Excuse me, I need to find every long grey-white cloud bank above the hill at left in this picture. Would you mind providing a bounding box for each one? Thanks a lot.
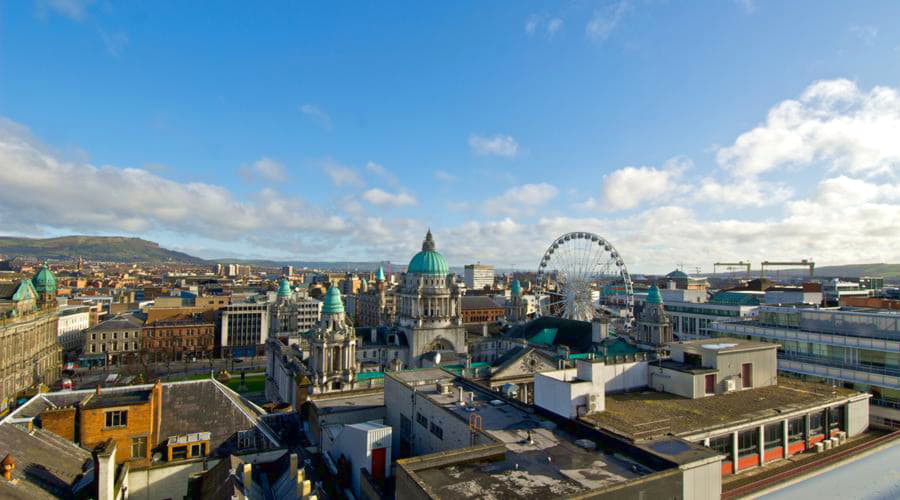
[0,120,347,240]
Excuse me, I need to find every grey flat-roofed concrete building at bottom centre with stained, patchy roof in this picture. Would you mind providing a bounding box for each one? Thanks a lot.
[384,368,721,499]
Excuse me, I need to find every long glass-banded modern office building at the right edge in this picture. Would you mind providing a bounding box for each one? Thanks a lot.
[713,306,900,428]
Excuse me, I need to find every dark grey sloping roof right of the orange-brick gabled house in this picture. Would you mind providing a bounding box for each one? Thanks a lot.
[156,379,277,456]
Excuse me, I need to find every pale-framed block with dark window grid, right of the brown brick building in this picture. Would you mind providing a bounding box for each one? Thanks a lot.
[217,302,271,357]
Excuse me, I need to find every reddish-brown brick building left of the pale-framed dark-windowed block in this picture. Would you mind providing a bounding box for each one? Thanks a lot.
[142,314,216,361]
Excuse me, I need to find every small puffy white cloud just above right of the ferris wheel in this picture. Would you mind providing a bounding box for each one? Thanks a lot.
[601,157,691,210]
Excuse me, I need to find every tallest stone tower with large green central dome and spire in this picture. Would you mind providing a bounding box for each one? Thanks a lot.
[397,230,467,367]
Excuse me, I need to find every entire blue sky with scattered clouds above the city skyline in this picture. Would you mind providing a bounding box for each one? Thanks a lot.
[0,0,900,272]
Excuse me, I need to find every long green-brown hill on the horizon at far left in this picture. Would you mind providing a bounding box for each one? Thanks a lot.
[0,236,204,264]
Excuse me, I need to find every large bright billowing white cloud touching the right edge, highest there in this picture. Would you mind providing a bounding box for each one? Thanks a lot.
[716,80,900,176]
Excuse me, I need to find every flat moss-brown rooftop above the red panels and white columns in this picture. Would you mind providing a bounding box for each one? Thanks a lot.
[583,378,860,441]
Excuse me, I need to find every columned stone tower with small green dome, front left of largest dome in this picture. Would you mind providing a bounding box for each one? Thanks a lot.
[309,286,359,393]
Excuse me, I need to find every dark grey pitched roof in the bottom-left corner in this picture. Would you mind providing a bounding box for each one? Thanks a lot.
[0,424,93,499]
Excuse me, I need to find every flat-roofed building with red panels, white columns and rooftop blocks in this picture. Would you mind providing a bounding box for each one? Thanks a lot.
[534,338,870,474]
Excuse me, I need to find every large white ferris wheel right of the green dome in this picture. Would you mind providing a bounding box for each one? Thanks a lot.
[537,232,634,325]
